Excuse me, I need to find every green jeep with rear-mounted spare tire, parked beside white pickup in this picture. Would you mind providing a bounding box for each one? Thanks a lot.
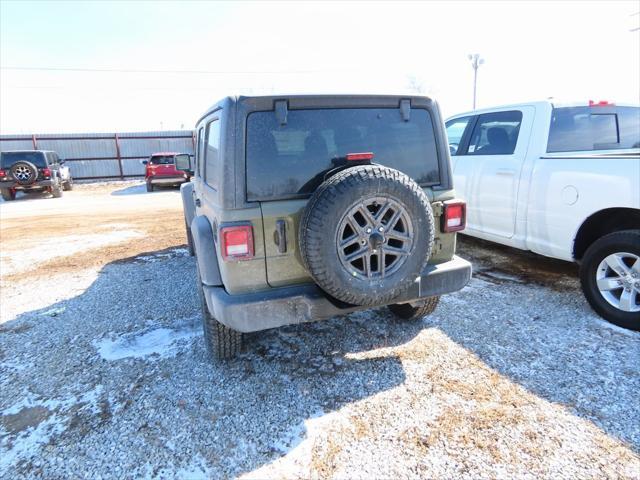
[176,95,471,359]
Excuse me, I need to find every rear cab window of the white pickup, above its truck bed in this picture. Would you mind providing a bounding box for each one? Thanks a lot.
[547,106,640,153]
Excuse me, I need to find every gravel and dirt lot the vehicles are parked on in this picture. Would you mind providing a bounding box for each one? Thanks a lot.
[0,183,640,479]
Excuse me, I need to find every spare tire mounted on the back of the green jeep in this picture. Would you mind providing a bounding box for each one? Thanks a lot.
[298,165,434,305]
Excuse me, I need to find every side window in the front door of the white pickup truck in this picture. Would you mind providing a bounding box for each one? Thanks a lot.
[467,110,522,155]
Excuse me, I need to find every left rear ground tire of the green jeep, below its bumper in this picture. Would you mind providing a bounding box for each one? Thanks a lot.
[196,263,244,360]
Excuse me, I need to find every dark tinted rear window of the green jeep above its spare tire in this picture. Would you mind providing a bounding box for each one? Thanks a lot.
[246,108,440,201]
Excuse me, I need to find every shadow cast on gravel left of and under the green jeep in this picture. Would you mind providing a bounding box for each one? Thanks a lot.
[0,251,412,477]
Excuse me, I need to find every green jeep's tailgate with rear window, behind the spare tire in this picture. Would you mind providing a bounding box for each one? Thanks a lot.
[246,107,440,287]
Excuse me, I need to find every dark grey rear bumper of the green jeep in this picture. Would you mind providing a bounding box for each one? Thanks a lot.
[204,256,471,332]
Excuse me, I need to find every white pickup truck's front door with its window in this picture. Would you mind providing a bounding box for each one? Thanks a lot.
[448,106,535,238]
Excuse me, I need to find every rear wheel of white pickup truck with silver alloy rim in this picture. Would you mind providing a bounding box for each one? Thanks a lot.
[580,230,640,331]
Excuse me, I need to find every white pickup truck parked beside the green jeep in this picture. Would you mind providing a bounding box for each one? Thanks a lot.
[446,101,640,330]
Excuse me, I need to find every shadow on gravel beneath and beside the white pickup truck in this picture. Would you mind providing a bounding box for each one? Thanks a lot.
[444,237,640,452]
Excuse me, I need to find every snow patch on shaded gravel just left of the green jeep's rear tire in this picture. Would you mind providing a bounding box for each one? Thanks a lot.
[94,326,199,361]
